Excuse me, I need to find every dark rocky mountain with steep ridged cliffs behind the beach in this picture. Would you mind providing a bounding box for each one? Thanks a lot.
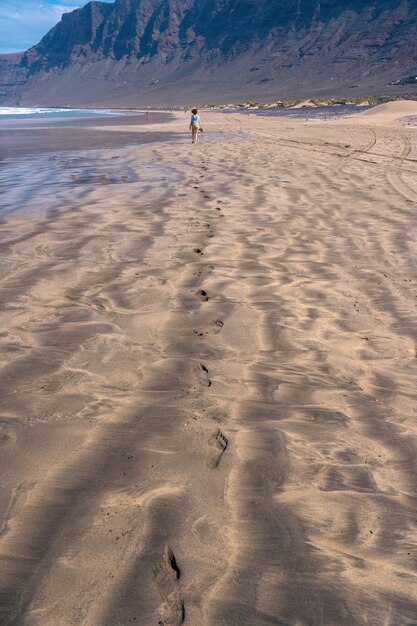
[0,0,417,106]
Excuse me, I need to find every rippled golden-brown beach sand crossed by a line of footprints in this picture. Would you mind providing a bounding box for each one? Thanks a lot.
[0,105,417,626]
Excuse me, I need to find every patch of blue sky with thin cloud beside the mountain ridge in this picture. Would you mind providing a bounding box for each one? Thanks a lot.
[0,0,113,53]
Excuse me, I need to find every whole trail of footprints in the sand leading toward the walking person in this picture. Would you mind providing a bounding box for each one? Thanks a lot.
[152,158,228,626]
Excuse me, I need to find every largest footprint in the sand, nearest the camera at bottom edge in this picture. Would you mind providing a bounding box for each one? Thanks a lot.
[152,546,185,626]
